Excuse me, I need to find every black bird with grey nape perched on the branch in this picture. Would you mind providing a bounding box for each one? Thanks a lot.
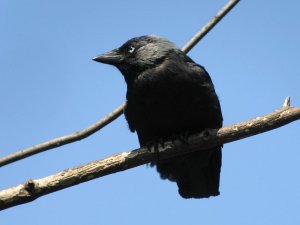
[94,35,223,198]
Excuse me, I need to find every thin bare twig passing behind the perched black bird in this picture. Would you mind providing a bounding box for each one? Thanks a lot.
[0,0,239,167]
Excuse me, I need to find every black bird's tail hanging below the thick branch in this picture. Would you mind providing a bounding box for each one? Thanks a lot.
[157,147,222,198]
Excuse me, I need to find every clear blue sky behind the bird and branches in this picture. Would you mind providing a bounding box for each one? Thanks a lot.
[0,0,300,225]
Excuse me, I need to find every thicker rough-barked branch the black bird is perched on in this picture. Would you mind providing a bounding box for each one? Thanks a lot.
[0,98,300,210]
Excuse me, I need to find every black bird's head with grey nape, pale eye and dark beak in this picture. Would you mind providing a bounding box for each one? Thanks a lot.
[93,35,180,79]
